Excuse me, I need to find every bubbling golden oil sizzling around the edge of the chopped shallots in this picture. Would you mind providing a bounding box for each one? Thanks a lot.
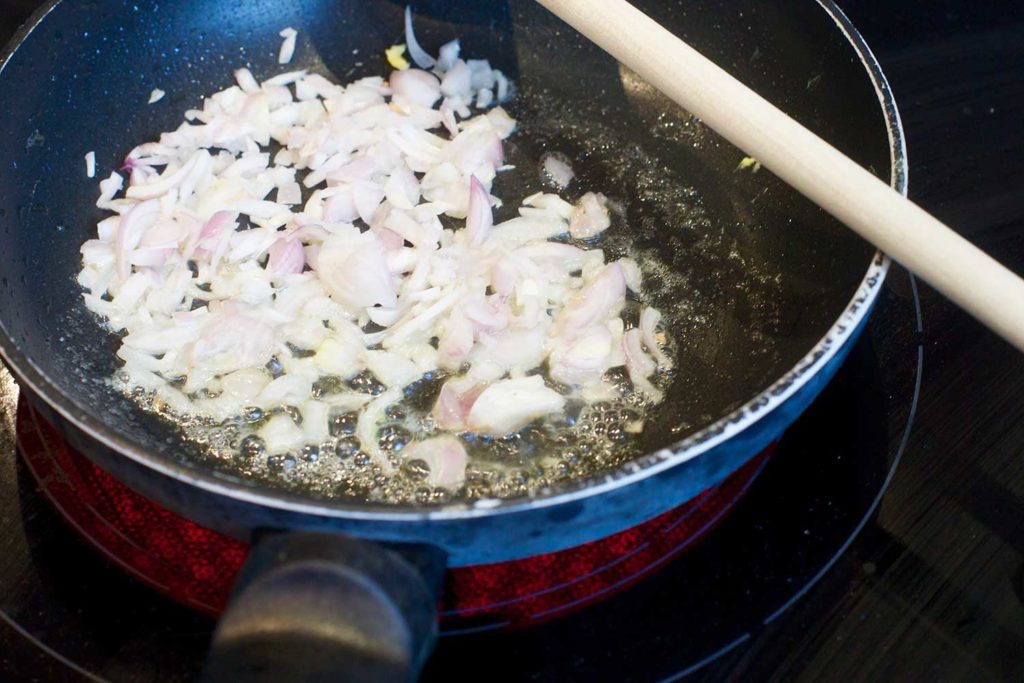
[110,82,761,504]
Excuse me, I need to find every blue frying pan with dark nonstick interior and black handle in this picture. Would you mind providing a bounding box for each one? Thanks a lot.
[0,0,906,680]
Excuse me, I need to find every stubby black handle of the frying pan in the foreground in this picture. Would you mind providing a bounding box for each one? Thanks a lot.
[201,531,446,683]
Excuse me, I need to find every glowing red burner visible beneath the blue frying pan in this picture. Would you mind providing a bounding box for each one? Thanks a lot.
[17,400,771,633]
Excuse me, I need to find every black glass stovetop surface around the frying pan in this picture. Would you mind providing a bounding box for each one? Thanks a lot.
[0,0,1024,682]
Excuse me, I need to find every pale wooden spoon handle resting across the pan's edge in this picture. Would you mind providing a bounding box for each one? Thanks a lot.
[538,0,1024,350]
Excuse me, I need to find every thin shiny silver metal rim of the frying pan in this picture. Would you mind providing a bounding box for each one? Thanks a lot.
[0,0,907,523]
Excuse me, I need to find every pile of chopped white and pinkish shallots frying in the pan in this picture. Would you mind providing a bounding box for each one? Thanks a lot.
[78,15,671,490]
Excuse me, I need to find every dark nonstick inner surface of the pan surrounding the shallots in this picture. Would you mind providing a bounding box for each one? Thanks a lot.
[0,0,890,504]
